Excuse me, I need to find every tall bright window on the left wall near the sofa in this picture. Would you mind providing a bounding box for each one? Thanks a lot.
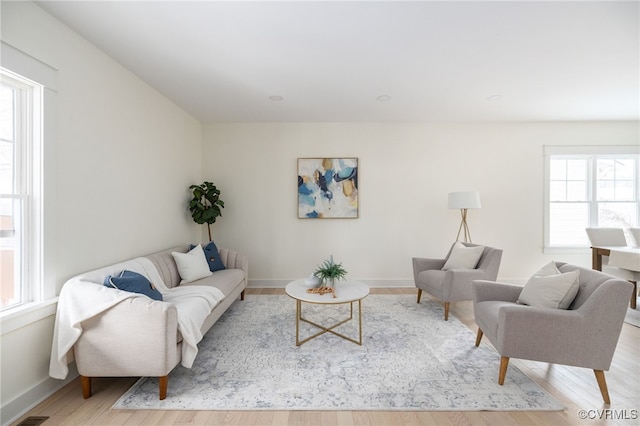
[0,68,43,310]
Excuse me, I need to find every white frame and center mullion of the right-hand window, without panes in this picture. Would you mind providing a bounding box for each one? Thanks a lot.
[543,145,640,253]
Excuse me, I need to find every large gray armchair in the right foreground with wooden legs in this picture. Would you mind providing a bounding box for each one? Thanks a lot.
[473,262,633,404]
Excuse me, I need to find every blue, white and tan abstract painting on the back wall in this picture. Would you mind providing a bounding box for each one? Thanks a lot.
[298,158,358,219]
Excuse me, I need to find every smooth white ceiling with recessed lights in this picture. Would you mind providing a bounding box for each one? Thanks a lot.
[37,1,640,122]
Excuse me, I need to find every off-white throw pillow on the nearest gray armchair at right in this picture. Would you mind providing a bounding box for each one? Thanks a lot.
[518,263,580,309]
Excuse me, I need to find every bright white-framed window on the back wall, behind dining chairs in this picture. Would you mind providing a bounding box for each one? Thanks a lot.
[545,146,640,249]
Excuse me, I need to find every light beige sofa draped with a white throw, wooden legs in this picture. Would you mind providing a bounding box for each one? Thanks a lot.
[49,245,248,399]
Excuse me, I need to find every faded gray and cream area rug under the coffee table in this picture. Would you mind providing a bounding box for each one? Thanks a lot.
[113,295,564,411]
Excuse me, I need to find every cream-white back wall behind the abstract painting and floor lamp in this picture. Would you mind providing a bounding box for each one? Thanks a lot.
[203,122,640,286]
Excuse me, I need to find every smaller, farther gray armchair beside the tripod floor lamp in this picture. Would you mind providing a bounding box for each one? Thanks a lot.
[413,243,502,321]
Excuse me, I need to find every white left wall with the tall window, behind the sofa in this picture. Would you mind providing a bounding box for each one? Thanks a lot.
[0,2,202,423]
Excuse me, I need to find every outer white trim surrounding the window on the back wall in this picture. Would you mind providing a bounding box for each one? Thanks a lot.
[543,145,640,254]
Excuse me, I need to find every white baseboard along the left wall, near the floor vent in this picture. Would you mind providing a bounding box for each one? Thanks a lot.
[0,362,82,426]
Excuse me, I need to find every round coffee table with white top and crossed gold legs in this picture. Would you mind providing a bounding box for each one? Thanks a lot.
[285,279,369,346]
